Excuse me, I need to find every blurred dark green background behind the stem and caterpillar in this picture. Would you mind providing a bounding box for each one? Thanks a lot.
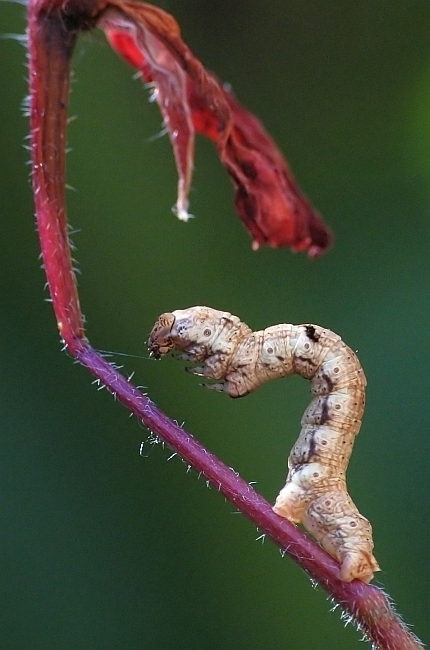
[0,0,430,650]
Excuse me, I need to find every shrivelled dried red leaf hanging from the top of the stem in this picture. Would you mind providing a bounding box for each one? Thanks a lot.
[98,0,331,257]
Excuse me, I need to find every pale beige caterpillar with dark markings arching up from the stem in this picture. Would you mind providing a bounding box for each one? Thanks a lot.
[148,307,379,582]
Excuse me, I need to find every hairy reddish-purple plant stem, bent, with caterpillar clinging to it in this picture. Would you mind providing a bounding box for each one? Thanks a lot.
[28,0,422,650]
